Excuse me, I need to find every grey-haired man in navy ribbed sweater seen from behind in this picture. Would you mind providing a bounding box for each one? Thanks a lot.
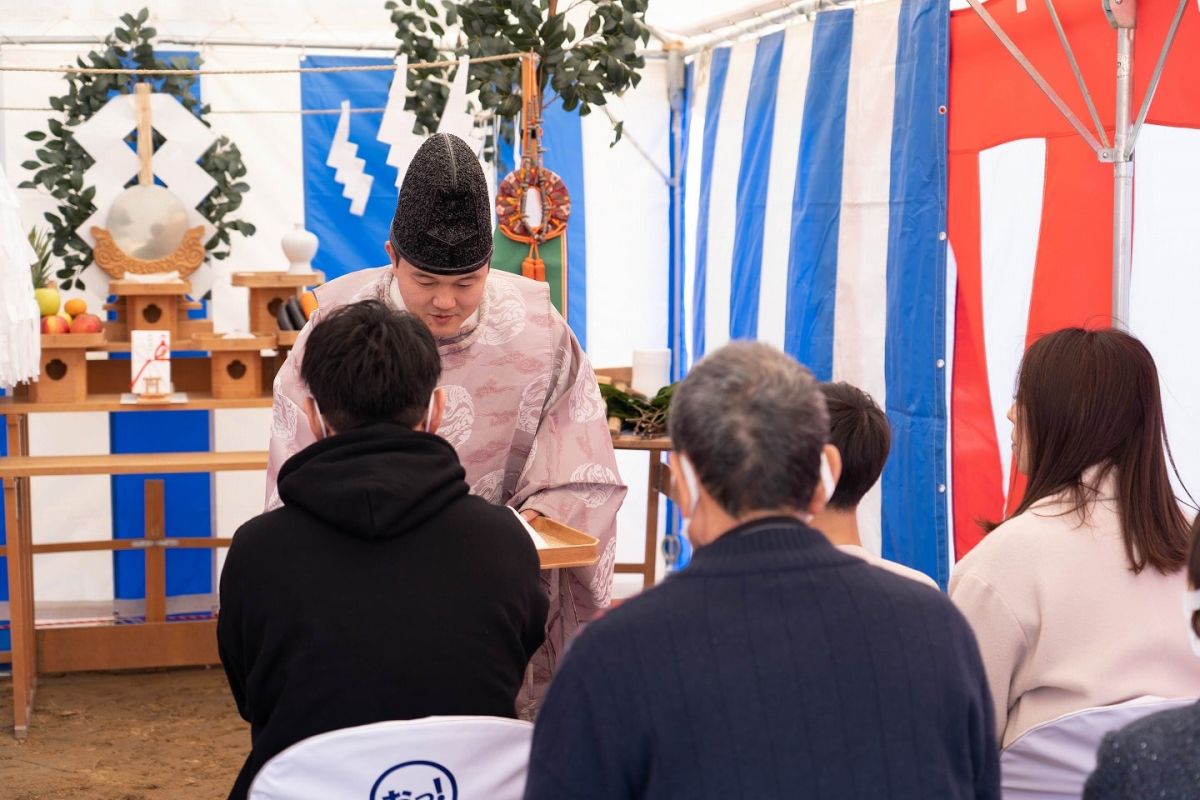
[526,343,1000,800]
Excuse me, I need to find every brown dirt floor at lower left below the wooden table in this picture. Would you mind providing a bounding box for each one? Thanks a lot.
[0,668,250,800]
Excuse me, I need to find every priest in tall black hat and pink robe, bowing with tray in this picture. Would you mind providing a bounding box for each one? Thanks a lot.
[266,133,625,718]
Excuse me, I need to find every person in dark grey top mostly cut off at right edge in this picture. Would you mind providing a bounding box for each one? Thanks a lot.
[1084,517,1200,800]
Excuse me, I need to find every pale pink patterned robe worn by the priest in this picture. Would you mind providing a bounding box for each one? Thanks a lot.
[266,267,625,718]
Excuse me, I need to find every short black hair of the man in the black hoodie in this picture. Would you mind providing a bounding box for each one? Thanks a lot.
[300,300,442,432]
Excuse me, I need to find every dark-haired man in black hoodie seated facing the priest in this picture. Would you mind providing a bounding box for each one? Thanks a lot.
[217,300,547,799]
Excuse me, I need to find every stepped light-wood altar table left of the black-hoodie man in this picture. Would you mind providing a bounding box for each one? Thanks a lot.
[0,393,271,738]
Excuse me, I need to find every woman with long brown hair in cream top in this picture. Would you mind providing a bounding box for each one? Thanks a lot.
[950,329,1200,746]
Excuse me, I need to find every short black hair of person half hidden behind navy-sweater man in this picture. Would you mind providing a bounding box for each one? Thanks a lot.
[821,383,892,511]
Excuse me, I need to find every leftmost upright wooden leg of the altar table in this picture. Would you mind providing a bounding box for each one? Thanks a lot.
[4,414,37,739]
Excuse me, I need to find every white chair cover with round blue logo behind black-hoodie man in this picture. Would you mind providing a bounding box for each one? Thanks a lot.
[250,716,533,800]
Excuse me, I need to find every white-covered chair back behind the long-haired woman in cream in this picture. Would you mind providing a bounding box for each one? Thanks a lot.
[1000,697,1195,800]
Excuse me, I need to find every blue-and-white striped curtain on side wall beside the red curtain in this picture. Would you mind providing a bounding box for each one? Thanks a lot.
[672,0,949,585]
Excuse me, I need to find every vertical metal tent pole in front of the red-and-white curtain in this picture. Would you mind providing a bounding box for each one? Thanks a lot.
[1112,28,1133,330]
